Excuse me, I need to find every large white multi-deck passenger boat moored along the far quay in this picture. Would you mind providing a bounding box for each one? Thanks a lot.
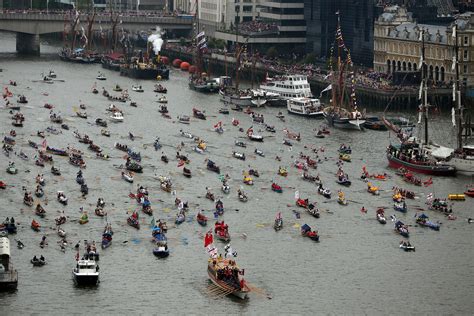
[260,75,313,106]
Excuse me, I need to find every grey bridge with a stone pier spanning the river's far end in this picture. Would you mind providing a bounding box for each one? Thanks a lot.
[0,12,193,55]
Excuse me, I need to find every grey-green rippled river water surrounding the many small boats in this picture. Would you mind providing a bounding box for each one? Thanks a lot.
[0,34,474,315]
